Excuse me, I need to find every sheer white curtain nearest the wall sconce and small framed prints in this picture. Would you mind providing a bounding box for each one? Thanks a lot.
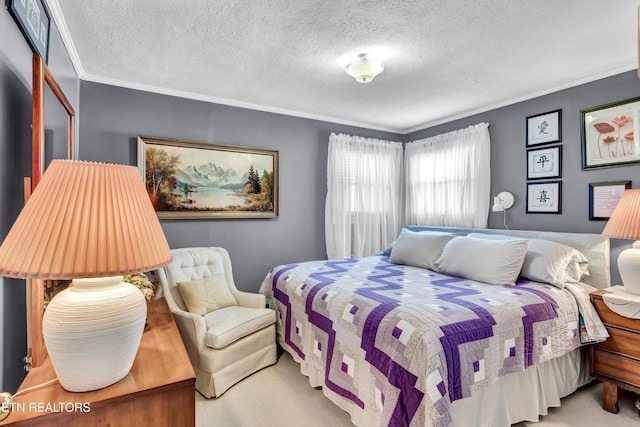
[405,123,491,228]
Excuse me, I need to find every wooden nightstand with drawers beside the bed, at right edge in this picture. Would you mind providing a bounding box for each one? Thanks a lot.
[589,290,640,414]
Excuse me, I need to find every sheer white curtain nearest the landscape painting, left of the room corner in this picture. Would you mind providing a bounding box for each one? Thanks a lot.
[325,133,402,259]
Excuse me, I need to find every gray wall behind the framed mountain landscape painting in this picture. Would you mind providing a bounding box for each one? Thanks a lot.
[79,81,401,292]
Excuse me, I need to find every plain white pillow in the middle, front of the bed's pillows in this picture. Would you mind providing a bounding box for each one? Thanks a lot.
[435,236,527,285]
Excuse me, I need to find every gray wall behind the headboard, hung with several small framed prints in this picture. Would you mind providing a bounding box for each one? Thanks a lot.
[404,71,640,284]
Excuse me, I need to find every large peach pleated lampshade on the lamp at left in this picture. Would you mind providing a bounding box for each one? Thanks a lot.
[0,160,171,280]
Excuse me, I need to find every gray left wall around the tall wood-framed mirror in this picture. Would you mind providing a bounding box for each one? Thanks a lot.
[0,7,80,392]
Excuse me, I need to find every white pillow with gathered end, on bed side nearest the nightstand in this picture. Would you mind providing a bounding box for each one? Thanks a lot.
[468,233,589,289]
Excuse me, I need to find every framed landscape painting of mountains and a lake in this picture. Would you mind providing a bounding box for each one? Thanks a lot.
[138,136,278,219]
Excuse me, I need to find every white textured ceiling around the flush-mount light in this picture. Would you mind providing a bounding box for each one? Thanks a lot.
[48,0,640,133]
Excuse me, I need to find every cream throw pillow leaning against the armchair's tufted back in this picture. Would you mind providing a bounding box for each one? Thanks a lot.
[176,273,238,315]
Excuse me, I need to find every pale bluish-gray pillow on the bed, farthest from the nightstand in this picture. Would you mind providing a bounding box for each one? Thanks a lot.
[389,228,453,270]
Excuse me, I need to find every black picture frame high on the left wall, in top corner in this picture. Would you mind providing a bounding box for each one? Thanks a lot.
[5,0,51,64]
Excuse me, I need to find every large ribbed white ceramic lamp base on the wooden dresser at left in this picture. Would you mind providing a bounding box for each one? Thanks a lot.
[42,276,147,392]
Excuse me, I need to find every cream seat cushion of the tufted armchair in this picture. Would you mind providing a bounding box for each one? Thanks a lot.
[204,306,276,349]
